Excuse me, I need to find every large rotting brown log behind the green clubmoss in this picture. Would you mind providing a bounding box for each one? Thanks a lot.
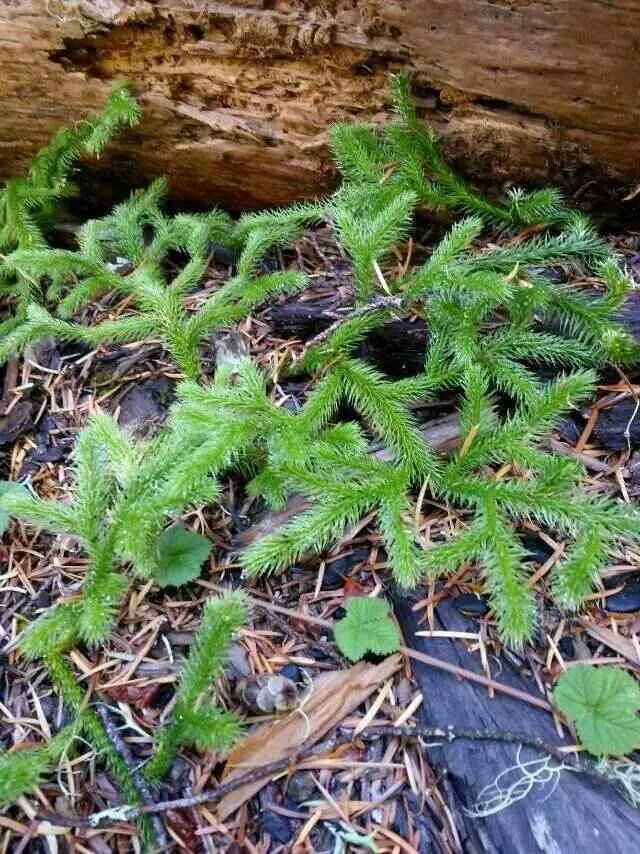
[0,0,640,208]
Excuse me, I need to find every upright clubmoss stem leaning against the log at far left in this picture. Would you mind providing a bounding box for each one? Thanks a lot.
[0,83,140,339]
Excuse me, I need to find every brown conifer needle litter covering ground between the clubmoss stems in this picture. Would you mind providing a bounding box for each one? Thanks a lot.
[0,219,640,854]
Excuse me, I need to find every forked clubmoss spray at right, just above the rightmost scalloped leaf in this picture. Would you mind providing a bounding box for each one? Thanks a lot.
[425,372,640,645]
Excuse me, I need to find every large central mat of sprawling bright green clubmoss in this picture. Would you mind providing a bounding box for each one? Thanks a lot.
[0,80,640,668]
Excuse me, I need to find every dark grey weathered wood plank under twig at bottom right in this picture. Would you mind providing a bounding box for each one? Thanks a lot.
[394,597,640,854]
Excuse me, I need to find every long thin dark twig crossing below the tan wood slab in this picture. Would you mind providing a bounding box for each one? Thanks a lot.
[41,726,610,828]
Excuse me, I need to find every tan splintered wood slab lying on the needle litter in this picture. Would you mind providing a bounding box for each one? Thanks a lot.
[217,655,402,821]
